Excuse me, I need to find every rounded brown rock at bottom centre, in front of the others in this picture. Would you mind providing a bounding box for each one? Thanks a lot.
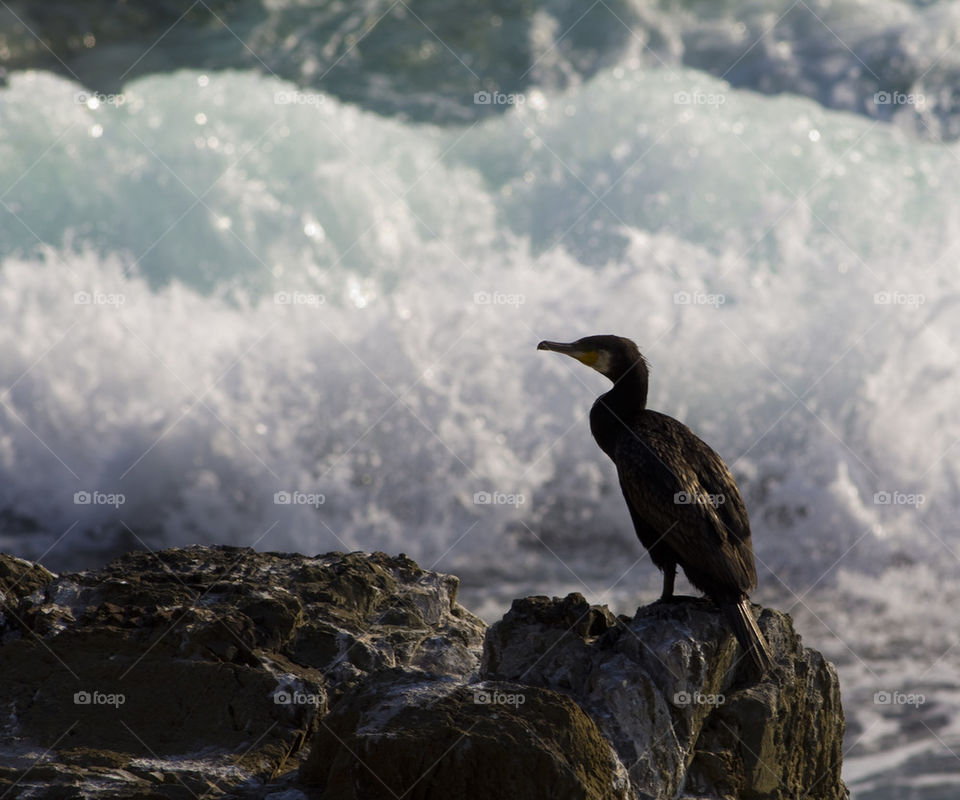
[300,672,631,800]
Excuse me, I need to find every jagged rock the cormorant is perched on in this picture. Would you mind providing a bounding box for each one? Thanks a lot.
[481,594,847,800]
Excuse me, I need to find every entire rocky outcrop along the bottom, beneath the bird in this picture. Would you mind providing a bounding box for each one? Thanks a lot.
[0,547,846,800]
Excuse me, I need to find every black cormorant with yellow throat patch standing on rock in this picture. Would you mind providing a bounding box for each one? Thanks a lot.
[537,336,773,674]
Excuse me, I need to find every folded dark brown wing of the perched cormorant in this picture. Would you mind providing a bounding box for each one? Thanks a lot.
[614,412,757,591]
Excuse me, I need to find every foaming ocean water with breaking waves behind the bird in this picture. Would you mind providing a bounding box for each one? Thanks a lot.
[0,2,960,800]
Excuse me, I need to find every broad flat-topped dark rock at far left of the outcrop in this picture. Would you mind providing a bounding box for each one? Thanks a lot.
[0,547,484,797]
